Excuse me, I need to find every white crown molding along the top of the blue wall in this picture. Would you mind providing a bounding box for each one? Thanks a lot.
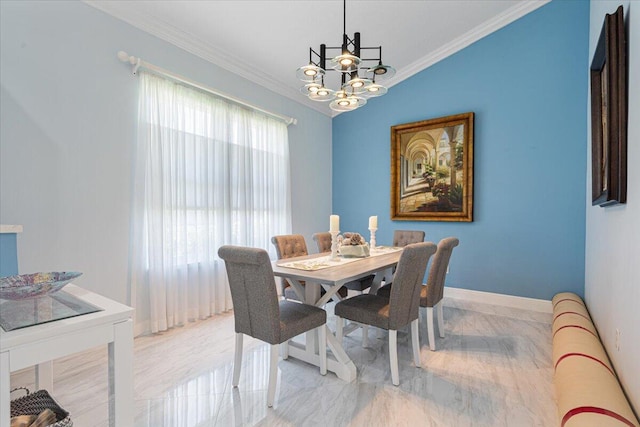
[386,0,551,87]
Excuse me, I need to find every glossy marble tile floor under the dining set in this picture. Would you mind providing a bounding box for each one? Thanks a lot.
[11,299,558,427]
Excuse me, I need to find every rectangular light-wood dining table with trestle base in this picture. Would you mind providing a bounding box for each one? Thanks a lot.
[272,246,403,382]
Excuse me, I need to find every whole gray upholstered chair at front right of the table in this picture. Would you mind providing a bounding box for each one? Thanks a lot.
[334,243,436,385]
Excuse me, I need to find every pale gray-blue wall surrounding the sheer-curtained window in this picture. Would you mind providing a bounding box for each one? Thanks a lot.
[0,1,331,302]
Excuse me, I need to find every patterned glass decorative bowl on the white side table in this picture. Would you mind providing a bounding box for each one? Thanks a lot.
[0,271,82,300]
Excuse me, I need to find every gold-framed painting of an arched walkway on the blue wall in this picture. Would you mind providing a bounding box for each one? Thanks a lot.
[391,113,473,222]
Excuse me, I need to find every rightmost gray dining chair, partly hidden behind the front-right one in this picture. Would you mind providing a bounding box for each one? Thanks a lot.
[377,237,460,351]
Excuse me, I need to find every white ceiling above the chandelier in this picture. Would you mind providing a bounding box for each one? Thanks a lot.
[86,0,549,115]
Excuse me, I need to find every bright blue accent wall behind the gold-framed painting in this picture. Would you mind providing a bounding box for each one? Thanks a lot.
[333,0,589,299]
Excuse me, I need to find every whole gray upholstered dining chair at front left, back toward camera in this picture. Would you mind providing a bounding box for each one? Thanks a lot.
[218,246,327,407]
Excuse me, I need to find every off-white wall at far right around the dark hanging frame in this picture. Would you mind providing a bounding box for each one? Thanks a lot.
[585,1,640,413]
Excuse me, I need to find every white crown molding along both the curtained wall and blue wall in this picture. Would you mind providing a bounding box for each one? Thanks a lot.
[83,0,551,118]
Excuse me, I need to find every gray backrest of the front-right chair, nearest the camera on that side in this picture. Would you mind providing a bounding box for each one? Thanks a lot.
[389,242,437,330]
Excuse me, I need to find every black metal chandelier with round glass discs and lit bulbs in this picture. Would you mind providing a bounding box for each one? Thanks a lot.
[296,0,396,112]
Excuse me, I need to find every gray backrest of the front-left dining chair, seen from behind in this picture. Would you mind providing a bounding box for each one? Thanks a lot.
[218,246,280,344]
